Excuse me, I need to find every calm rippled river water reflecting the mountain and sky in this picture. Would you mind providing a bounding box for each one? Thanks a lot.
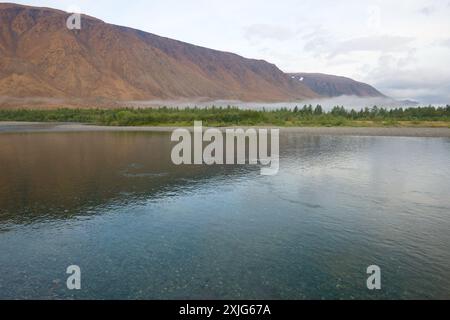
[0,133,450,299]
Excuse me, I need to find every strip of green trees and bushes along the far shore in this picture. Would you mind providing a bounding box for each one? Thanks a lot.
[0,105,450,127]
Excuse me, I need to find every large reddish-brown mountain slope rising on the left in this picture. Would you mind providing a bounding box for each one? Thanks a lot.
[0,4,318,102]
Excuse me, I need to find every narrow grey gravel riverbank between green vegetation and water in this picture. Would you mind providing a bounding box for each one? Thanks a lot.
[0,121,450,137]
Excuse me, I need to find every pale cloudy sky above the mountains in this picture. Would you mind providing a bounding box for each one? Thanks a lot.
[12,0,450,103]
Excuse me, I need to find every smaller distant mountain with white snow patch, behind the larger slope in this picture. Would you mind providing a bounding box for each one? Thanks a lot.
[290,73,385,97]
